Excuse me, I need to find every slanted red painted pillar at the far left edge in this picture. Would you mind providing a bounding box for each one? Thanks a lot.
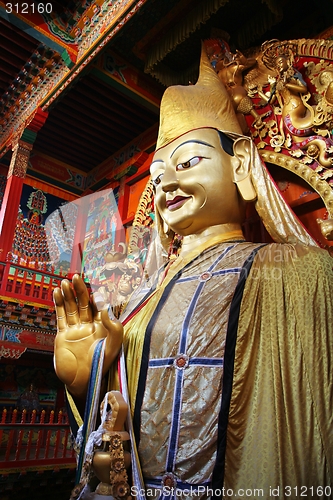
[0,141,32,261]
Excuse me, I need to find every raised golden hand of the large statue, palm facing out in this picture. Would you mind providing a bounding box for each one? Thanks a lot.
[53,274,123,398]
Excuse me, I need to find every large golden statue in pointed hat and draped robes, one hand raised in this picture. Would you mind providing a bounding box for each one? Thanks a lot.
[54,45,333,499]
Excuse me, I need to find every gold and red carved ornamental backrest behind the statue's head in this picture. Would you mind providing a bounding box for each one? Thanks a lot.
[219,39,333,240]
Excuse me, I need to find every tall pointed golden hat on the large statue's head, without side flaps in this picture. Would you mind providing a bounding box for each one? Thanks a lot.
[156,45,242,149]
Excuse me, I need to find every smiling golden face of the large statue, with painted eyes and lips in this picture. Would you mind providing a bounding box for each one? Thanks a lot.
[151,128,240,236]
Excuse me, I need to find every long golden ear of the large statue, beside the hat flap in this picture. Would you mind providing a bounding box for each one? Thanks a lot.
[231,138,257,201]
